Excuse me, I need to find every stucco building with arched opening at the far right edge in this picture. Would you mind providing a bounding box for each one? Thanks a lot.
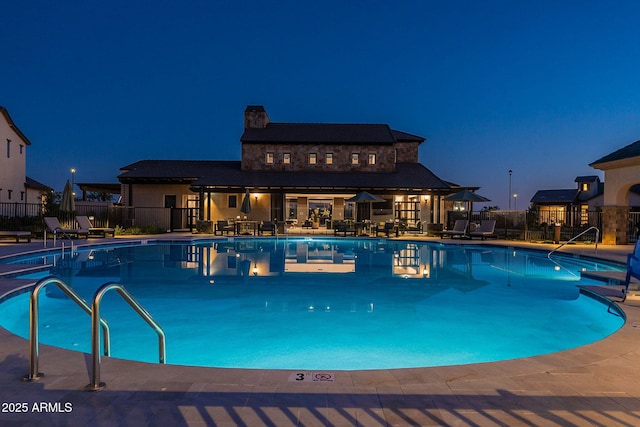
[589,141,640,244]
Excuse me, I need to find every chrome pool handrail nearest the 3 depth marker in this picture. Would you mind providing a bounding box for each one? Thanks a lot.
[85,282,166,391]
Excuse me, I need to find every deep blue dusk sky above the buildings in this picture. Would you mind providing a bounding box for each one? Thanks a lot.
[0,0,640,208]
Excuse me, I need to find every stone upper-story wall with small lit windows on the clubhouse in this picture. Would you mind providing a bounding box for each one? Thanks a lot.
[242,143,418,172]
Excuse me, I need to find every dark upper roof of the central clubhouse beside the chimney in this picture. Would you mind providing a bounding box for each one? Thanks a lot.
[240,123,425,145]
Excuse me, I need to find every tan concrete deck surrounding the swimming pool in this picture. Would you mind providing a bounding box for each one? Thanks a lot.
[0,233,640,427]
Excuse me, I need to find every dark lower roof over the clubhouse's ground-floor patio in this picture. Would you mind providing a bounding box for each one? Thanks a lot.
[118,160,451,191]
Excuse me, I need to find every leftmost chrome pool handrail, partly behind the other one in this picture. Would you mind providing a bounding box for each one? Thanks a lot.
[22,276,111,382]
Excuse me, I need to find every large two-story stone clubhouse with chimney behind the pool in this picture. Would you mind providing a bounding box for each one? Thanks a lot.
[118,106,470,231]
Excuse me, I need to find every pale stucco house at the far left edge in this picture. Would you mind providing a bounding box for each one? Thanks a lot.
[0,106,50,211]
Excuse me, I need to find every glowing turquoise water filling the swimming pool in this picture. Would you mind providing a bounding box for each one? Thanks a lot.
[0,238,624,370]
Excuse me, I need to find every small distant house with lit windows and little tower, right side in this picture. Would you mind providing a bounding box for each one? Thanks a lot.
[531,175,604,226]
